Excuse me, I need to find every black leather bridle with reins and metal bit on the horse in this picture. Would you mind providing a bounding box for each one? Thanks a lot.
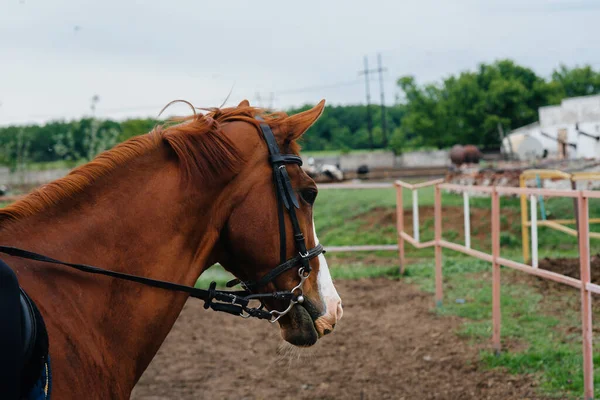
[0,117,325,323]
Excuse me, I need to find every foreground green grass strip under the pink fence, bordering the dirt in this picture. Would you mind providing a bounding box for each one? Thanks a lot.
[406,258,600,399]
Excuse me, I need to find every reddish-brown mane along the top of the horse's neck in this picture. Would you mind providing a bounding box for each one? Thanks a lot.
[0,103,300,222]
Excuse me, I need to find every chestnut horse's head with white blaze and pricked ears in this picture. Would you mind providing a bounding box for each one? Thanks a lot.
[217,101,342,346]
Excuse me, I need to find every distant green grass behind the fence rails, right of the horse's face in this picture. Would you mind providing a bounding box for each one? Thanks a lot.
[314,188,600,261]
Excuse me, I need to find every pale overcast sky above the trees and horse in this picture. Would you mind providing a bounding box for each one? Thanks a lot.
[0,0,600,125]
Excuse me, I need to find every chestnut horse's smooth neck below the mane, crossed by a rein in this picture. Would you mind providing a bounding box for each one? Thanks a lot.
[0,146,229,388]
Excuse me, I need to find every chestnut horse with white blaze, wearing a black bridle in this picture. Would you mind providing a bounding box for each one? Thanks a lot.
[0,100,343,399]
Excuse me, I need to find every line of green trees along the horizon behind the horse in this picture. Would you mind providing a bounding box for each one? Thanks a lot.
[0,60,600,167]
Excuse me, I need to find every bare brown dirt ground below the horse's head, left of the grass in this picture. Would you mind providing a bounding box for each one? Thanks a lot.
[132,278,543,400]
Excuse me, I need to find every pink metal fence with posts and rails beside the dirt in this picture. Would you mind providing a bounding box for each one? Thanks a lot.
[395,181,600,400]
